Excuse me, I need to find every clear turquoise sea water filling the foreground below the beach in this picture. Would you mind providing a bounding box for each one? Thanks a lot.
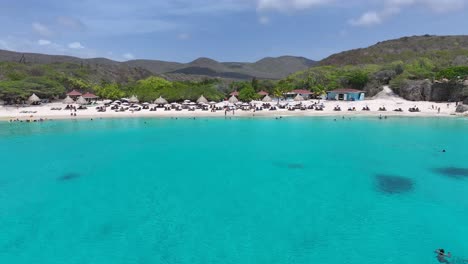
[0,118,468,264]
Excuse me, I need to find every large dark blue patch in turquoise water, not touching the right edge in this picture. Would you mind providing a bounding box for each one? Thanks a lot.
[375,174,414,194]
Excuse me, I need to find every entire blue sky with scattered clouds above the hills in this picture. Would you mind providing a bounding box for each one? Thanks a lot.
[0,0,468,62]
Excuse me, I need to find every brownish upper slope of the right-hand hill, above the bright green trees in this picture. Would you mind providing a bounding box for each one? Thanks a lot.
[319,35,468,66]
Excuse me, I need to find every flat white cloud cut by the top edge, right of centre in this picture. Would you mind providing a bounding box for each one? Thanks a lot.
[257,0,334,11]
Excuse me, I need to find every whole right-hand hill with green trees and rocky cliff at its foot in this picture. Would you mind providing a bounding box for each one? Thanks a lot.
[279,35,468,101]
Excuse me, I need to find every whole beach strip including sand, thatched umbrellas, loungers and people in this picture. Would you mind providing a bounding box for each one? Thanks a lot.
[0,87,466,122]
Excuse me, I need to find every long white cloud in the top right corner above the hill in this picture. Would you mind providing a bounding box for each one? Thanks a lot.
[349,0,467,26]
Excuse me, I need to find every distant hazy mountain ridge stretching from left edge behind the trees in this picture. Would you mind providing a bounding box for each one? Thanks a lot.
[0,50,316,80]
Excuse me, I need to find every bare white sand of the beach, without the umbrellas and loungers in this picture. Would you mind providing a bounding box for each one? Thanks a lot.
[0,86,463,121]
